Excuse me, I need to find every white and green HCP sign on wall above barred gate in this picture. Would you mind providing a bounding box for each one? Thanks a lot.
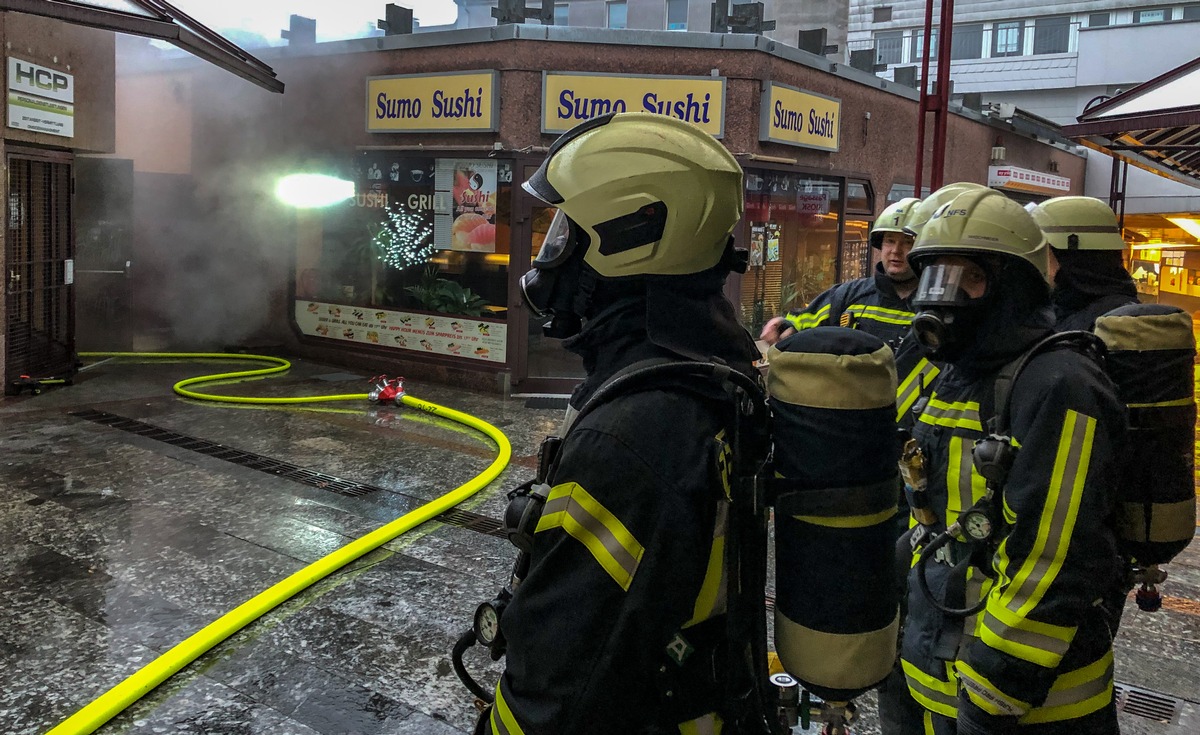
[8,56,74,138]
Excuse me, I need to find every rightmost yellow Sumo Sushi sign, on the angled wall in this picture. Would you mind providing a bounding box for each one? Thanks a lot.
[758,82,841,151]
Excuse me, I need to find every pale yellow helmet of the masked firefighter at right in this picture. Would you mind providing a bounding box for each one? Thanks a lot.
[908,184,1049,280]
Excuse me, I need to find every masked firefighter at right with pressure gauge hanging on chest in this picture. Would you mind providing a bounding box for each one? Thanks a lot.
[901,189,1126,735]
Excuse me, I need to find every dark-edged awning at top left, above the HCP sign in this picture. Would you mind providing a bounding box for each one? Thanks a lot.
[0,0,283,92]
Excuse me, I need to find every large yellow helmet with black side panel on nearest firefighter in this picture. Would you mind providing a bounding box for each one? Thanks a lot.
[523,113,743,277]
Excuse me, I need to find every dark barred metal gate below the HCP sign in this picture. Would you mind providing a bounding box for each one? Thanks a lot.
[5,149,76,394]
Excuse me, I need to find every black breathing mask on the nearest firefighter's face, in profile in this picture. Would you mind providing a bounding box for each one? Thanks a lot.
[521,210,592,340]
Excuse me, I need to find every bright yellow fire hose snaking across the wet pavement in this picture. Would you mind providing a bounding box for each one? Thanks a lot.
[47,352,512,735]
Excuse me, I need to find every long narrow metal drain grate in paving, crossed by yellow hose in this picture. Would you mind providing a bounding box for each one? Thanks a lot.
[71,408,505,538]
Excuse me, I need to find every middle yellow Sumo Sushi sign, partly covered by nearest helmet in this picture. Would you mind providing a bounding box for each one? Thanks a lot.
[541,72,725,138]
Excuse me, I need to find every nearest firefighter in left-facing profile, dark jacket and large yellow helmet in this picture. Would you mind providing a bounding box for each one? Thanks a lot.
[478,113,766,735]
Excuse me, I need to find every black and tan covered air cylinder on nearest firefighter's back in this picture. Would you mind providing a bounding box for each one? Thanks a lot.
[767,327,900,701]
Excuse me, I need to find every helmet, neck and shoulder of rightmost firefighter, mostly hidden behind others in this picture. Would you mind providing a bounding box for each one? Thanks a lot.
[1030,197,1138,331]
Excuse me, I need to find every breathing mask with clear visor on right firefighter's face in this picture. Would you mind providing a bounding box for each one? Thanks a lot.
[912,261,995,360]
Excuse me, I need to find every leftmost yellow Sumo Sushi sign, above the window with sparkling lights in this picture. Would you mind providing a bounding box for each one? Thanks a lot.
[367,71,499,132]
